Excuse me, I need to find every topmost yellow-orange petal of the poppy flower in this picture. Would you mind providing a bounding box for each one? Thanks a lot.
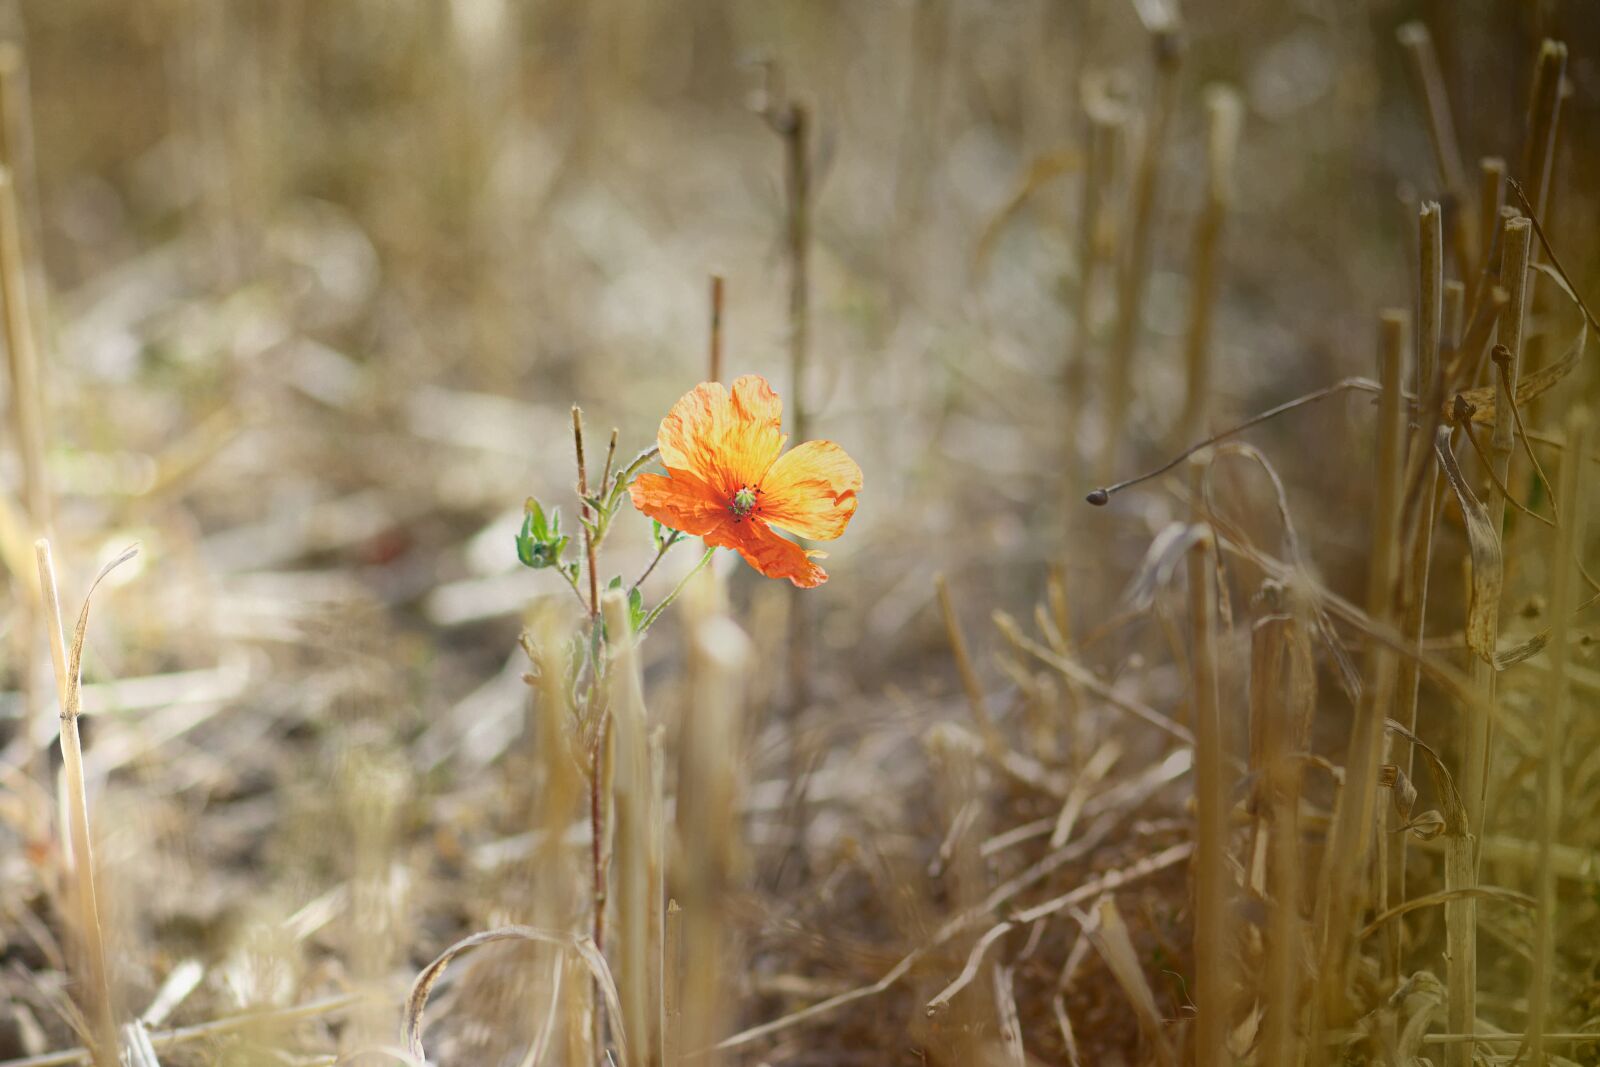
[656,374,784,496]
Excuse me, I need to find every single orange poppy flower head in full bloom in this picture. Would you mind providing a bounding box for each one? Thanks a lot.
[629,374,861,589]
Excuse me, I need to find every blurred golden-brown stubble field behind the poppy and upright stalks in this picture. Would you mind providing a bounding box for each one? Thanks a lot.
[0,0,1600,1065]
